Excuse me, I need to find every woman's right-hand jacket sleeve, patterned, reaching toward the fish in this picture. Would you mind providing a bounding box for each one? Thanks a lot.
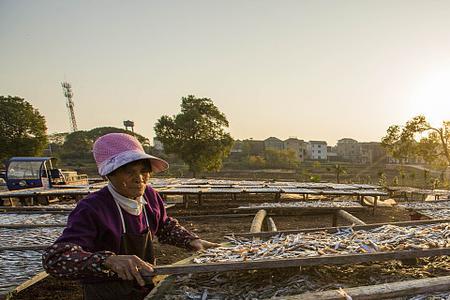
[155,193,199,250]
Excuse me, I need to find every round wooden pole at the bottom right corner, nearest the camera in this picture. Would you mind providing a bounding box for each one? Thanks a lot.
[280,276,450,300]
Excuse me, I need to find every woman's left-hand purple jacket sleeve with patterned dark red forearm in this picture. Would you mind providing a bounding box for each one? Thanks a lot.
[42,203,114,279]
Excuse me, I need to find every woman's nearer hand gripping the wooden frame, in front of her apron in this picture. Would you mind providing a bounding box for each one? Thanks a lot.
[104,255,153,286]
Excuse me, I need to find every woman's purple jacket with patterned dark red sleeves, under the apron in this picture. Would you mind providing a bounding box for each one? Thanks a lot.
[43,186,198,281]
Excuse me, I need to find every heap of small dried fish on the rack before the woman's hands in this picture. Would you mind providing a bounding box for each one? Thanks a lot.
[193,223,450,264]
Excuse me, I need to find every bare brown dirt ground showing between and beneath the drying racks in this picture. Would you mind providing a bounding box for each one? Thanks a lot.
[13,196,410,300]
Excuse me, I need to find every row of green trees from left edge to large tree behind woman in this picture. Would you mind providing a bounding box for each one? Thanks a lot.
[0,95,233,175]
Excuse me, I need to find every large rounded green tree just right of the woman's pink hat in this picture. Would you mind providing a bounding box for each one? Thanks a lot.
[155,95,233,177]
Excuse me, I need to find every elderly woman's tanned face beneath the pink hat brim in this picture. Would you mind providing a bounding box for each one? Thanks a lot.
[108,160,151,199]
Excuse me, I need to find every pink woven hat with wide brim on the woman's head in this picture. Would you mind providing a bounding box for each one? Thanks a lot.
[93,133,169,176]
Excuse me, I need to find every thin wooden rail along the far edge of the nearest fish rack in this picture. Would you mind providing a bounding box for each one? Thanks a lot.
[234,219,450,237]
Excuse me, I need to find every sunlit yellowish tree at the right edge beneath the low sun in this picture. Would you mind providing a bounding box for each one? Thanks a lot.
[381,115,450,166]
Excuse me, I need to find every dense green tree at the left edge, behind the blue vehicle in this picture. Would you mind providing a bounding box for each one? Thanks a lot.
[0,96,47,161]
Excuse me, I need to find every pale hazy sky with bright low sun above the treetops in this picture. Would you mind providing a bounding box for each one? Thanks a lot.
[0,0,450,144]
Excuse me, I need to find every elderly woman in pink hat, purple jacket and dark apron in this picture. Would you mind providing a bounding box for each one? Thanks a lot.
[43,133,217,300]
